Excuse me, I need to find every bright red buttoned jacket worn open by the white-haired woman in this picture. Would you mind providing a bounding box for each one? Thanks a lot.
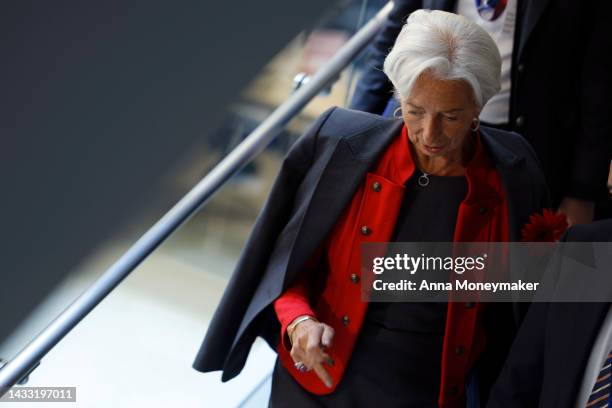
[274,126,508,408]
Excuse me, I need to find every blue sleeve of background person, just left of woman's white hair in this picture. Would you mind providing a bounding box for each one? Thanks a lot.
[349,0,422,114]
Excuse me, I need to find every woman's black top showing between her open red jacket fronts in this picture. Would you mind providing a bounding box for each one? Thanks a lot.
[353,171,467,407]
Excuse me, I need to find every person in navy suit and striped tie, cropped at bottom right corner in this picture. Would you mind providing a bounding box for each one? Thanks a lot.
[487,219,612,408]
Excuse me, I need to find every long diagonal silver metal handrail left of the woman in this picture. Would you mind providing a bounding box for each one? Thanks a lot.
[0,2,393,397]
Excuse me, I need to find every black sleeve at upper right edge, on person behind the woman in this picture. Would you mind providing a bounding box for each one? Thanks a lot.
[566,1,612,200]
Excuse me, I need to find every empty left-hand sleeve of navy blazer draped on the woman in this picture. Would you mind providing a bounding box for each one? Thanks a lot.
[192,107,335,374]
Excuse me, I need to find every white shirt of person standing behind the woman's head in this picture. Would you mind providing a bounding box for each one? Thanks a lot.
[455,0,517,124]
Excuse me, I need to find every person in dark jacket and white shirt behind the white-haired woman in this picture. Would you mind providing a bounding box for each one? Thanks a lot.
[349,0,612,225]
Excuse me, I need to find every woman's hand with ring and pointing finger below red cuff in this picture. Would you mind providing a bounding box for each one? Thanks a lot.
[289,319,334,388]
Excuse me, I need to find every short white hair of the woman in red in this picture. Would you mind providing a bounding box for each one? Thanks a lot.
[384,10,501,109]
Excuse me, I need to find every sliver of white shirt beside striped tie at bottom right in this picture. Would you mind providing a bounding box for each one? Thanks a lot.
[575,306,612,408]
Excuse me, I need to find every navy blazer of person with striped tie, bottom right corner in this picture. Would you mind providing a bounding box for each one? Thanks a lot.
[487,219,612,408]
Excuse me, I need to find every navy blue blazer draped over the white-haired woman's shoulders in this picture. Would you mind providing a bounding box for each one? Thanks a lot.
[193,108,550,400]
